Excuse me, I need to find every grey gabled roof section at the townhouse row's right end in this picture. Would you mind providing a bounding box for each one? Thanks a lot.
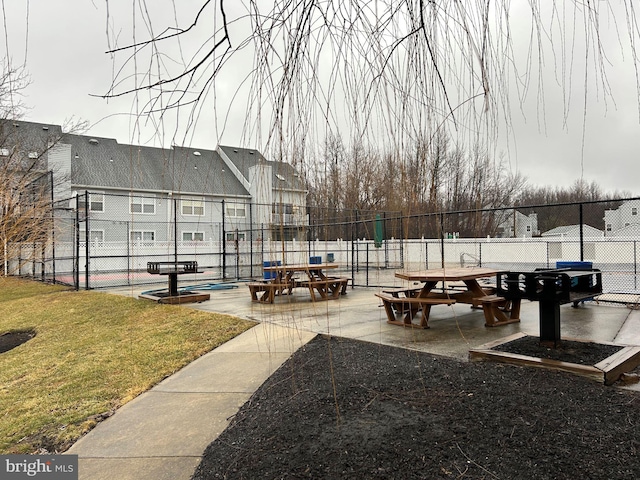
[218,145,304,191]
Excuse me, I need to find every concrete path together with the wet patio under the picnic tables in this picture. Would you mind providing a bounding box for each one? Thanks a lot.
[67,285,640,480]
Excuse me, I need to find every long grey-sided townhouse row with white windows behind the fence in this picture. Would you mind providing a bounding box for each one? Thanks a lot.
[0,121,308,243]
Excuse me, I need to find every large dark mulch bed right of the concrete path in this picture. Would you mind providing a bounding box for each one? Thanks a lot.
[193,337,640,480]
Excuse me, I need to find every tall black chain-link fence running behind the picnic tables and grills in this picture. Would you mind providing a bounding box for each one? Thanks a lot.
[10,192,640,293]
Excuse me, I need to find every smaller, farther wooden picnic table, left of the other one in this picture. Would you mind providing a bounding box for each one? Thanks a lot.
[249,263,349,303]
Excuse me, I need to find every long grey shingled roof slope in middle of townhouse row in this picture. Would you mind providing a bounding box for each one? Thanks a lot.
[68,135,249,196]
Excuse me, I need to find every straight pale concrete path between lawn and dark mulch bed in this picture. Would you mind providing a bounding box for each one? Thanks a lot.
[66,323,315,480]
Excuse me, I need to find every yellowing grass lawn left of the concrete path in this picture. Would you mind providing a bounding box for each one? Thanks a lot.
[0,278,254,454]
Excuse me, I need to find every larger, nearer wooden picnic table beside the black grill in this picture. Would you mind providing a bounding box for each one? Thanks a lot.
[376,267,520,328]
